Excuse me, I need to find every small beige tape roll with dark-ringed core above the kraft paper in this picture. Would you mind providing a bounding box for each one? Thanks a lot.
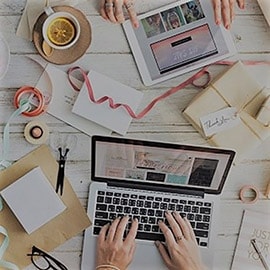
[24,120,49,144]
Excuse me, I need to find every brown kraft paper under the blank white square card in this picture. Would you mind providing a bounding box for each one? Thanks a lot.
[0,145,91,268]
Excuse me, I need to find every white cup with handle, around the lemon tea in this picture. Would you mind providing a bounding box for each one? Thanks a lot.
[42,6,81,50]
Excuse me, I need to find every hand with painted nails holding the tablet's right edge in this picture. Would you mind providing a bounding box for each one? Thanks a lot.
[212,0,245,29]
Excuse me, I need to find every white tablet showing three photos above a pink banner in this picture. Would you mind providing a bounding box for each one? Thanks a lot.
[123,0,236,85]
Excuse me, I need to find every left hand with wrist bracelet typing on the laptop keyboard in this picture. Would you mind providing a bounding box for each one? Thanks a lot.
[96,216,138,270]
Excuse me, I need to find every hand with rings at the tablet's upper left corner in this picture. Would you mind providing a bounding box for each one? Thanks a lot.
[100,0,139,28]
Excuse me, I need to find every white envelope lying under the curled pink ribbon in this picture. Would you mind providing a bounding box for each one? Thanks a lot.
[72,70,143,135]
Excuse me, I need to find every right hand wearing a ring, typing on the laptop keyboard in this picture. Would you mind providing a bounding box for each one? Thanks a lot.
[156,212,204,270]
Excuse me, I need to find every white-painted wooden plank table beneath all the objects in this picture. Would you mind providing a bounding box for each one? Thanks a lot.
[0,0,270,270]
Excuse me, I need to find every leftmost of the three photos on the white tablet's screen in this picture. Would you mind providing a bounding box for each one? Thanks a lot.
[141,13,165,38]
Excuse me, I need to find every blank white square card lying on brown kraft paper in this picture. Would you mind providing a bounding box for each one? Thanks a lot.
[0,167,66,234]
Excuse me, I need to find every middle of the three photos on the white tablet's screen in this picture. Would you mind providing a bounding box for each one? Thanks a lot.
[161,7,185,31]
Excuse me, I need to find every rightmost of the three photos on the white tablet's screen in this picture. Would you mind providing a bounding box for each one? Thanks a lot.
[181,0,205,23]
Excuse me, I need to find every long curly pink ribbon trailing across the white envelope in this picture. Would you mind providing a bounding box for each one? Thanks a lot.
[68,60,270,119]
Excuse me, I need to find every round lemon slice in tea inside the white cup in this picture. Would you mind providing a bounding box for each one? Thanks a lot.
[47,17,75,46]
